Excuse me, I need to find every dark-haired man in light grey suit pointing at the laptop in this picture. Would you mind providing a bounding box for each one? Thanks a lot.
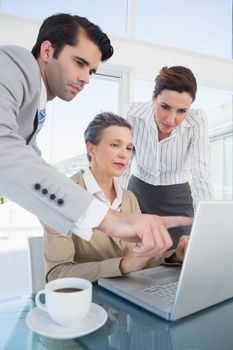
[0,14,191,256]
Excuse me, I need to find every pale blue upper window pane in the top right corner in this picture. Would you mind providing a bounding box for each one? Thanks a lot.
[135,0,232,58]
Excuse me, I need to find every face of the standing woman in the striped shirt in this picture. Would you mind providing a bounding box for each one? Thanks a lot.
[153,90,193,139]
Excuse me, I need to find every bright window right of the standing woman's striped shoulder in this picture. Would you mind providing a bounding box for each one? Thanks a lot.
[193,87,233,199]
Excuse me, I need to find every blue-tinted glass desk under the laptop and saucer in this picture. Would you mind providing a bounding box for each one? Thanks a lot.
[0,285,233,350]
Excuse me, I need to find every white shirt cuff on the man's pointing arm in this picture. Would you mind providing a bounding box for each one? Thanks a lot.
[71,198,109,241]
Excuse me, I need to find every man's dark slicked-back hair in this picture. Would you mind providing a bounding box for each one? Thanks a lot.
[32,13,113,62]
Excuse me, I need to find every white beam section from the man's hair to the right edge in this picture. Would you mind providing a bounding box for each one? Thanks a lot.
[111,37,233,91]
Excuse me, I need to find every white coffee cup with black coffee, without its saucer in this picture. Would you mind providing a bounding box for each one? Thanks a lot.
[35,278,92,326]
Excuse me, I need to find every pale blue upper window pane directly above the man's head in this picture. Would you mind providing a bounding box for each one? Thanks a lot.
[0,0,127,35]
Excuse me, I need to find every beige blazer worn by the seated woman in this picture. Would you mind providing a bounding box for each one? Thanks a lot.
[44,172,173,281]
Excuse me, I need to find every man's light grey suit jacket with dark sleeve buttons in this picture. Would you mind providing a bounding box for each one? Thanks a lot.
[0,46,92,234]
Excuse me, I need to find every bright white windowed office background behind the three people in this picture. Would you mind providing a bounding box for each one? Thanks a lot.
[0,0,233,296]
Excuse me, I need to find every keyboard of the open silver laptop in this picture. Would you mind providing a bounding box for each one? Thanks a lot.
[143,281,178,303]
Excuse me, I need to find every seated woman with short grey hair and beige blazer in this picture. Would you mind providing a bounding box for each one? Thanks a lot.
[44,113,188,281]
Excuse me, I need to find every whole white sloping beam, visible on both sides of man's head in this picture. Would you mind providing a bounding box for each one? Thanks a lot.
[0,13,233,91]
